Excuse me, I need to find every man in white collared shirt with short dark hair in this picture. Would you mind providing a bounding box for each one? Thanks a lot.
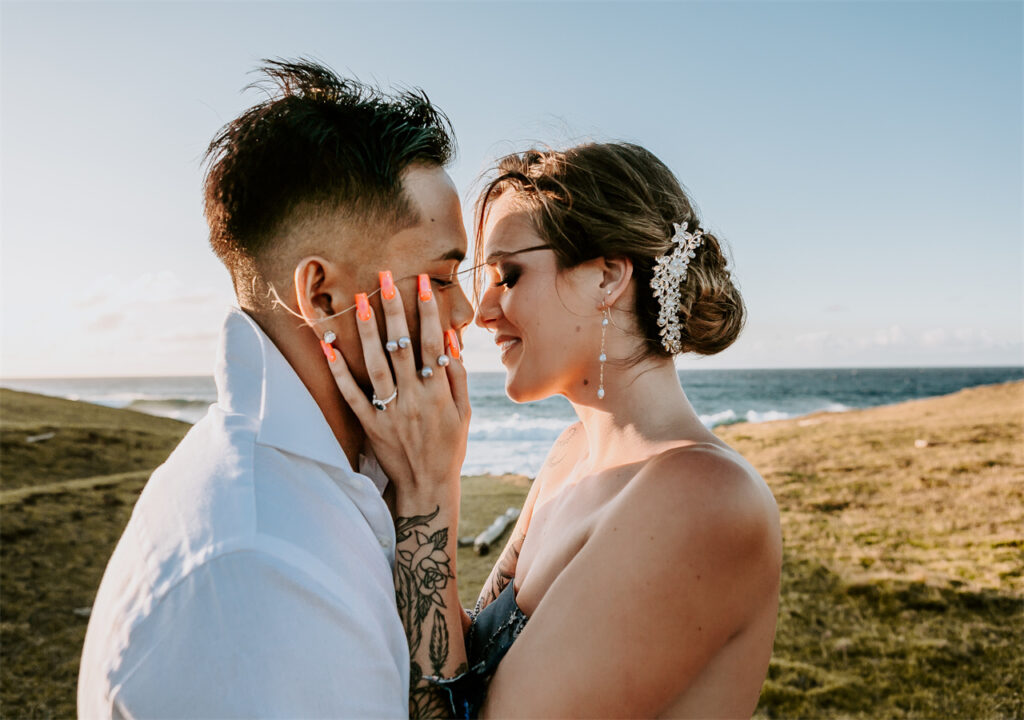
[78,61,472,718]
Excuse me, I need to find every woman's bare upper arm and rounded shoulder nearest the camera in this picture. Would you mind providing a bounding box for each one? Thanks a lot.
[484,453,777,717]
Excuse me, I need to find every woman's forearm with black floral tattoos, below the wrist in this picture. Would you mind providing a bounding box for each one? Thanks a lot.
[394,505,466,718]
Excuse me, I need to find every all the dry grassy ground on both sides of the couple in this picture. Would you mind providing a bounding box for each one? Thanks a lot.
[0,383,1024,718]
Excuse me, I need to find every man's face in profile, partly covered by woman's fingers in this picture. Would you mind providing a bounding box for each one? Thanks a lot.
[319,166,473,385]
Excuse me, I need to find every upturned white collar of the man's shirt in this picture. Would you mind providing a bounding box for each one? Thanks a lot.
[214,307,354,475]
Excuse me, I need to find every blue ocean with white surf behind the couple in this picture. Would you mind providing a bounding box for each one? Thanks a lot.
[0,367,1024,477]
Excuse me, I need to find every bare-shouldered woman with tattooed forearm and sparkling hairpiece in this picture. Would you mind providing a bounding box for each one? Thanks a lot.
[335,143,781,717]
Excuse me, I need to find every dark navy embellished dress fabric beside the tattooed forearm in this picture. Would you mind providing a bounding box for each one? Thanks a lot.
[432,582,527,718]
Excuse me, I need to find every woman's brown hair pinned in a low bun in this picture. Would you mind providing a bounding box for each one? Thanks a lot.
[474,142,746,359]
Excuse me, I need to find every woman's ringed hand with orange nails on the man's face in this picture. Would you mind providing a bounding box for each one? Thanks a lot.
[328,271,470,504]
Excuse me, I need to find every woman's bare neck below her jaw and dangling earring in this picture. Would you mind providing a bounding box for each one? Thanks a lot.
[569,358,712,474]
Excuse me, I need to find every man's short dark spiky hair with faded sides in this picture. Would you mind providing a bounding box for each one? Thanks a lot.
[205,59,454,288]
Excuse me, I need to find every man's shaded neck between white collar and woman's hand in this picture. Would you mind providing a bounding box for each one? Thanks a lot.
[247,310,366,471]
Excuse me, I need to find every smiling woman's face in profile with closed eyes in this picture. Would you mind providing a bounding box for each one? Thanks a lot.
[475,192,601,403]
